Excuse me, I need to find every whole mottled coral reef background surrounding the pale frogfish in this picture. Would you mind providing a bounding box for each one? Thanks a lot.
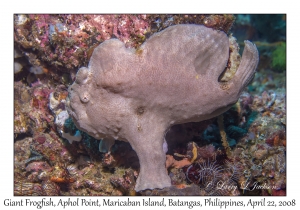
[14,14,288,196]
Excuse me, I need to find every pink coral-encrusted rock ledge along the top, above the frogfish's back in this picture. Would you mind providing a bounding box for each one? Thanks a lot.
[14,14,235,72]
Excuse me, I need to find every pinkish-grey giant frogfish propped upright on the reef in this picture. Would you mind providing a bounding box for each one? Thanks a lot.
[69,25,258,191]
